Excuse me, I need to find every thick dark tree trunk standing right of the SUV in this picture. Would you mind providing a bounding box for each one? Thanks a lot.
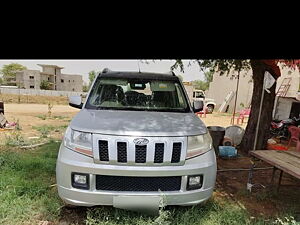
[240,60,277,153]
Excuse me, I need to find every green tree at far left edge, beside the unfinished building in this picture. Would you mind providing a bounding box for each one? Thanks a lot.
[0,63,27,85]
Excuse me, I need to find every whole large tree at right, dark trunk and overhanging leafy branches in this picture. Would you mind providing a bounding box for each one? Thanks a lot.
[171,59,300,152]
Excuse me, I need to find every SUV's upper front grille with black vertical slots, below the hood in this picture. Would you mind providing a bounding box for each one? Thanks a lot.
[93,134,186,166]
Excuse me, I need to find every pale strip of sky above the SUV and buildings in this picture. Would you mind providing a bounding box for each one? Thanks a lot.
[0,60,204,83]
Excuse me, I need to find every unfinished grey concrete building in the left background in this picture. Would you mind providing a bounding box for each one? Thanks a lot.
[16,64,83,92]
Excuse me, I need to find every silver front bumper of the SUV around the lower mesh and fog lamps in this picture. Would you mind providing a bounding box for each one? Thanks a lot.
[56,144,216,206]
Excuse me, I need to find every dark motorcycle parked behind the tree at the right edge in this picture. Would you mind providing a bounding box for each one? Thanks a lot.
[270,117,300,140]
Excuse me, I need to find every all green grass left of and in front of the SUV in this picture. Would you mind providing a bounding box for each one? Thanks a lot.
[0,142,297,225]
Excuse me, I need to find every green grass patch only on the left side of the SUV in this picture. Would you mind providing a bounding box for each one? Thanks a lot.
[0,142,62,224]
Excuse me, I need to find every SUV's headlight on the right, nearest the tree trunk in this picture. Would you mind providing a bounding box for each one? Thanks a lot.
[186,133,212,159]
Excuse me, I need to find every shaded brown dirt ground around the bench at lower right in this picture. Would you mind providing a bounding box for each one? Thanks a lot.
[216,156,300,219]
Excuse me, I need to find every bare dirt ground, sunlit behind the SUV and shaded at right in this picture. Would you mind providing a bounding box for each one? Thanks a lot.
[0,103,300,220]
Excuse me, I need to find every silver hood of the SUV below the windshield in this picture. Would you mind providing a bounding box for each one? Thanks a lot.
[70,109,207,136]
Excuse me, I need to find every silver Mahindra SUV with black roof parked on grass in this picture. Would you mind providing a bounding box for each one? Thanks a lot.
[56,70,216,207]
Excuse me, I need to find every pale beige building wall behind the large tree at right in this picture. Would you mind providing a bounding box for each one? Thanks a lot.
[207,62,300,117]
